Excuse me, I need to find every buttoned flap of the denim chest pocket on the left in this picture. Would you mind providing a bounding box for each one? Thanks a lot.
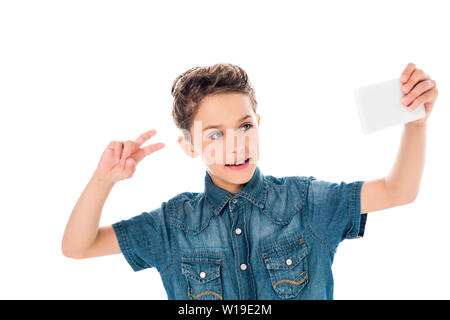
[181,256,221,283]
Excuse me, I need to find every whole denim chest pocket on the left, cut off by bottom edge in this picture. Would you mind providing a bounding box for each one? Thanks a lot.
[181,254,223,300]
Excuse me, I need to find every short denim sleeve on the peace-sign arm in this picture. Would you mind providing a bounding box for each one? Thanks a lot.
[112,203,171,271]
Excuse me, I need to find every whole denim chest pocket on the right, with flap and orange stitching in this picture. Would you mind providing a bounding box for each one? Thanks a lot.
[259,235,309,299]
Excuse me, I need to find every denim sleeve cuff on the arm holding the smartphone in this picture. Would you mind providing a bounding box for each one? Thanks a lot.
[346,181,367,239]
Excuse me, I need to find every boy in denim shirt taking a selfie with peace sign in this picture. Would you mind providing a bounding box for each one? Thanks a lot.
[62,63,437,300]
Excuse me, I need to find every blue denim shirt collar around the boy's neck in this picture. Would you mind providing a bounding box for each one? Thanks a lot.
[205,166,267,215]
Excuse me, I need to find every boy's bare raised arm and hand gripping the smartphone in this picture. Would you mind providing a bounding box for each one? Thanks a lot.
[361,63,438,213]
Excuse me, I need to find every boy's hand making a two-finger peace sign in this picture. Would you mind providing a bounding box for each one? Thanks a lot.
[96,129,165,183]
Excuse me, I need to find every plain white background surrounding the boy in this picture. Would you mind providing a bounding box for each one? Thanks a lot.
[0,0,450,299]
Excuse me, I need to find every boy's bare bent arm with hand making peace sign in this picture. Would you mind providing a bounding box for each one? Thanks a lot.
[61,130,164,259]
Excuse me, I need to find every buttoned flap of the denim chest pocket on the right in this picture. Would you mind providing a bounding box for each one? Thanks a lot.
[261,237,307,270]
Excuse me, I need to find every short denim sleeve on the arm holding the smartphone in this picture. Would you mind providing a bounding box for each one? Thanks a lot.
[307,178,367,251]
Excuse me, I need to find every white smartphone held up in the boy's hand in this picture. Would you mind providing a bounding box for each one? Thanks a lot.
[355,78,426,134]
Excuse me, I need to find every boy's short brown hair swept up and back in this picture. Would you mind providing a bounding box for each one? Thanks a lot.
[172,63,257,138]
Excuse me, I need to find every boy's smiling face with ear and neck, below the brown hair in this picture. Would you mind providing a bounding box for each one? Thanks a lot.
[178,93,259,193]
